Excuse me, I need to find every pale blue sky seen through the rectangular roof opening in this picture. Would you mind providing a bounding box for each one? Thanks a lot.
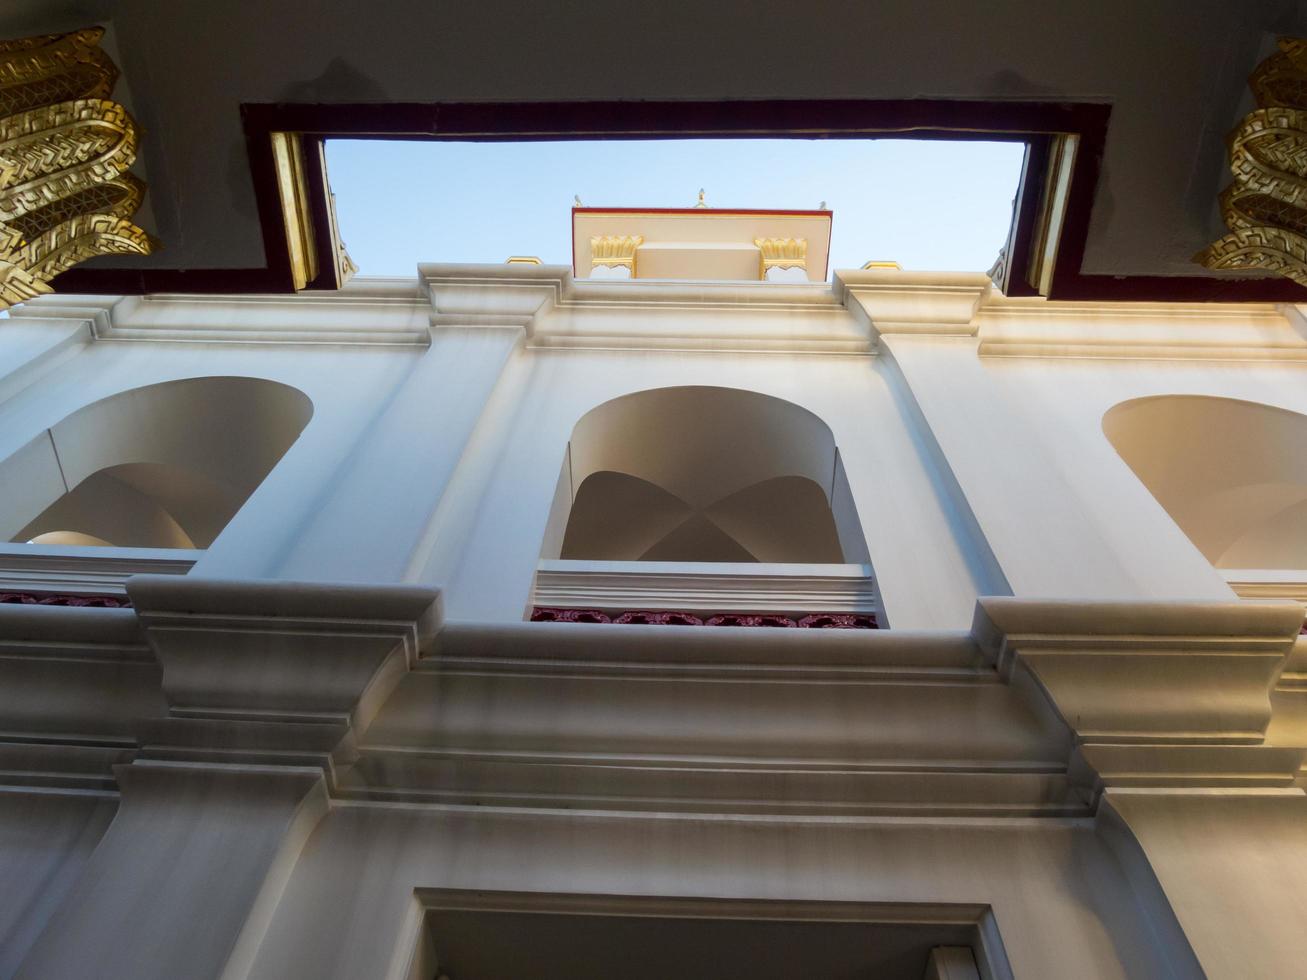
[327,140,1022,276]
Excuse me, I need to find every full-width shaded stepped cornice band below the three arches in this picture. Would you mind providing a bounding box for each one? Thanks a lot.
[0,590,1307,819]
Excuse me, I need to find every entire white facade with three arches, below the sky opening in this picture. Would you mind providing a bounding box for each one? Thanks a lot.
[0,264,1307,980]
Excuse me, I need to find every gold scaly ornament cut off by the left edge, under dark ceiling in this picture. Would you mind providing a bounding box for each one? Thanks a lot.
[0,27,157,310]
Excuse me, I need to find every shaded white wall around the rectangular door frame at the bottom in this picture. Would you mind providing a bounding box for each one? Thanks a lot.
[240,805,1176,980]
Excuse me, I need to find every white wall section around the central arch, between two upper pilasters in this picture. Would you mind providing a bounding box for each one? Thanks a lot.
[420,349,984,629]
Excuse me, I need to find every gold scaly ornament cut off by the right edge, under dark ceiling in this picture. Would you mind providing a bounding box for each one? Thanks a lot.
[1193,38,1307,286]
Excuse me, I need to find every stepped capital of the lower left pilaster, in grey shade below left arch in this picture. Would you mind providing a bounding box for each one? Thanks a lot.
[127,575,440,776]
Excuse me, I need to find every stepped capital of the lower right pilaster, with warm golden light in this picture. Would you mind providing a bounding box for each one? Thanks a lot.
[972,597,1307,794]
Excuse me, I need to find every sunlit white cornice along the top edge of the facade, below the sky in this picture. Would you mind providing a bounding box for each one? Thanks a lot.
[13,264,1307,362]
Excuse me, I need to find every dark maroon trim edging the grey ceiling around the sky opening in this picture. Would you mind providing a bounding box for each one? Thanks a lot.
[54,99,1307,302]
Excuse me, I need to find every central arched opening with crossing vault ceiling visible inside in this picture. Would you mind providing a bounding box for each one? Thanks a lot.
[542,385,868,563]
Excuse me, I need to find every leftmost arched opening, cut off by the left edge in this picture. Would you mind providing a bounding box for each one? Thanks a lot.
[0,378,312,547]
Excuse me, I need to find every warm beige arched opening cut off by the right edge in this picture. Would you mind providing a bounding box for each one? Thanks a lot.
[1103,395,1307,568]
